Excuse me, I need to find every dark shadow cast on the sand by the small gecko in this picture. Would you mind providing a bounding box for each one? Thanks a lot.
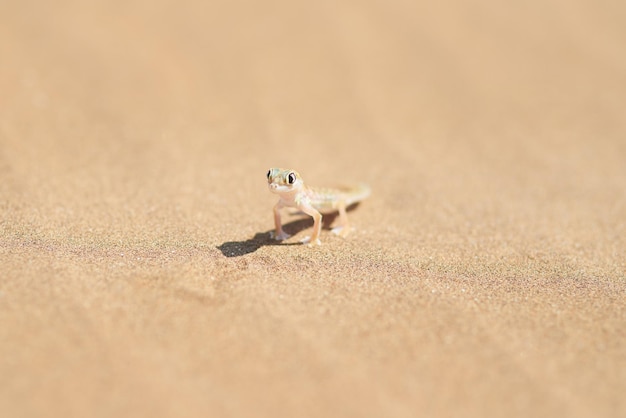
[217,203,358,258]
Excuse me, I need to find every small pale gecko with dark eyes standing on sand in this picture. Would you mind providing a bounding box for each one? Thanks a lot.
[267,168,370,245]
